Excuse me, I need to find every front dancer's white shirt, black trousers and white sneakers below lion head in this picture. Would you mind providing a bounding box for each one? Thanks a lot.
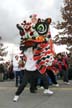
[13,48,53,102]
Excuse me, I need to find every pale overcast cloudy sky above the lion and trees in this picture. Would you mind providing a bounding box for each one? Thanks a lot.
[0,0,66,60]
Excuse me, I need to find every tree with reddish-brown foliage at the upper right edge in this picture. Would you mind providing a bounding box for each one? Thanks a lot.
[54,0,72,52]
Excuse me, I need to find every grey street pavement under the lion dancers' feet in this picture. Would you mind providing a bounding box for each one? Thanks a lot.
[0,80,72,108]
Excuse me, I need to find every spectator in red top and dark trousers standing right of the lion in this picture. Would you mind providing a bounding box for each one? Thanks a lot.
[57,53,70,84]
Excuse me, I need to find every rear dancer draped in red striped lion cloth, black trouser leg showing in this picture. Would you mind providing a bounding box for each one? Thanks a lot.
[34,38,59,86]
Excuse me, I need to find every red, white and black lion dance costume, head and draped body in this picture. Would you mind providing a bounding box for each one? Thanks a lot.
[16,14,57,74]
